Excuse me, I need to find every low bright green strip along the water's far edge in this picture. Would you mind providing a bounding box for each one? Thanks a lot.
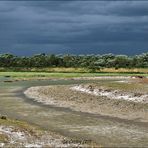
[0,72,148,82]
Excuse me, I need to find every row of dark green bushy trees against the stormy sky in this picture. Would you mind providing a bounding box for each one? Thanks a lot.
[0,53,148,69]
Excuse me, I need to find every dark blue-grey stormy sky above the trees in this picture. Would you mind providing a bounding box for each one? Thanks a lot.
[0,1,148,55]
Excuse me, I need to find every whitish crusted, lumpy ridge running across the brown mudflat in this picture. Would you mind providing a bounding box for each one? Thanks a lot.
[70,85,148,104]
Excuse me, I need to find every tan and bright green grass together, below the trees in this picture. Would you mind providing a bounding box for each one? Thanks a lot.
[0,68,148,79]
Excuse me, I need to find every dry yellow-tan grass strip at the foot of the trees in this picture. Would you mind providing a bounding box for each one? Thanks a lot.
[0,67,148,73]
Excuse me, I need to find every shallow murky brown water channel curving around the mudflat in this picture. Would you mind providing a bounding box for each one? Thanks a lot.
[0,78,148,147]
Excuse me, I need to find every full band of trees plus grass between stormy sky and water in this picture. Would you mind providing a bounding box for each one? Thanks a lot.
[0,53,148,78]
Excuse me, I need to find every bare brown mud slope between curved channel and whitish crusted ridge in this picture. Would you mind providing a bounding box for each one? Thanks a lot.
[24,85,148,122]
